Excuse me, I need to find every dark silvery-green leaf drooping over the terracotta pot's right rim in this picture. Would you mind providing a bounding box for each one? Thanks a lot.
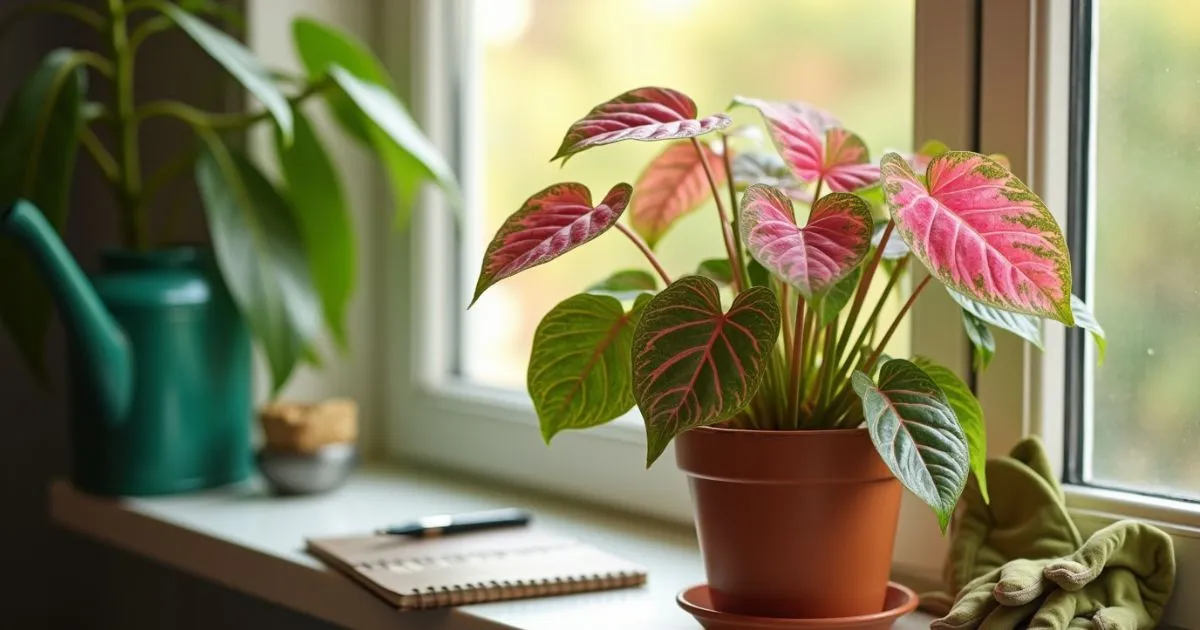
[851,359,971,532]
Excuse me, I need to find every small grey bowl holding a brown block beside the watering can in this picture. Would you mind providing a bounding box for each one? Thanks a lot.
[257,444,358,496]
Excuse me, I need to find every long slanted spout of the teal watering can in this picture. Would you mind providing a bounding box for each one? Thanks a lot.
[0,200,133,422]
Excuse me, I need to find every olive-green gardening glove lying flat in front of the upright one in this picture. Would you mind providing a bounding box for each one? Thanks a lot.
[931,521,1175,630]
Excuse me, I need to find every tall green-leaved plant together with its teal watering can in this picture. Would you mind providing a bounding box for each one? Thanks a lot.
[0,0,457,494]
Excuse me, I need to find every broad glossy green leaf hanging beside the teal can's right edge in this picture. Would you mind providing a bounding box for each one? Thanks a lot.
[196,139,322,391]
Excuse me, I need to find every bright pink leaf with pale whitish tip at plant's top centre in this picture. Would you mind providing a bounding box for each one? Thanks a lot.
[733,96,880,192]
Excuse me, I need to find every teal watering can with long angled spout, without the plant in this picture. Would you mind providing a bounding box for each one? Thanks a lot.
[0,202,253,494]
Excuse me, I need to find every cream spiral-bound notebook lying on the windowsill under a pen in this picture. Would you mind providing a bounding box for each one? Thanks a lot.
[307,528,646,610]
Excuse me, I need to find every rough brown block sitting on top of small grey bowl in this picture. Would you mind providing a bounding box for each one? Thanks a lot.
[258,398,359,452]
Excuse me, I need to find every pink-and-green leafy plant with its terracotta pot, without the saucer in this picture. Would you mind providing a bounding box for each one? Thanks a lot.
[475,88,1103,619]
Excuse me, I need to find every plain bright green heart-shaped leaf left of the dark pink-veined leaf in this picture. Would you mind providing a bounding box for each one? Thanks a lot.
[526,293,650,444]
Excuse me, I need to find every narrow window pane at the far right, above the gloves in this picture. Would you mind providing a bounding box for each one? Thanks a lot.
[1085,0,1200,499]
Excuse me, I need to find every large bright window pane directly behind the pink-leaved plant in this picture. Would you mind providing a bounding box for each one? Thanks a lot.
[462,0,914,388]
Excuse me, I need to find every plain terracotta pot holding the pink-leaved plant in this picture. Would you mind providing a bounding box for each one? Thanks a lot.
[676,427,901,619]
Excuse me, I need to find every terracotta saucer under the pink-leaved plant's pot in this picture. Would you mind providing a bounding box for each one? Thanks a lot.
[676,582,917,630]
